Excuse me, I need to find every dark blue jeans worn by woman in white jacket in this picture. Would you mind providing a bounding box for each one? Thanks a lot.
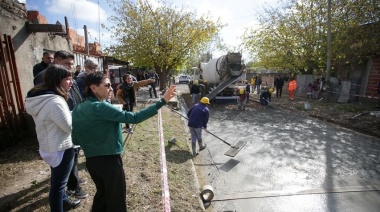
[49,148,74,212]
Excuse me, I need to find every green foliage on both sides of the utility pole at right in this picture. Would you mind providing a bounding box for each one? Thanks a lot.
[244,0,380,78]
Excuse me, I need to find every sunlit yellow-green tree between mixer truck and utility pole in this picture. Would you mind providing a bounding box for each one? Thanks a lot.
[245,0,325,74]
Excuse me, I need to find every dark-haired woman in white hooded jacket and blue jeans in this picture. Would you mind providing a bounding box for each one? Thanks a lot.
[25,65,80,211]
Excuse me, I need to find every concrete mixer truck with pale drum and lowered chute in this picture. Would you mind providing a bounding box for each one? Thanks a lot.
[193,53,245,100]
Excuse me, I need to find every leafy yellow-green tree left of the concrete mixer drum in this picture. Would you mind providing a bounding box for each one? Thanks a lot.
[104,0,222,90]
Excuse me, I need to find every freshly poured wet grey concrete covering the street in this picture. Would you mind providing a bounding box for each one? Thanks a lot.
[174,84,380,211]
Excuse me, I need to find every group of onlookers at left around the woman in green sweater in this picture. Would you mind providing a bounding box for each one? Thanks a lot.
[25,51,176,211]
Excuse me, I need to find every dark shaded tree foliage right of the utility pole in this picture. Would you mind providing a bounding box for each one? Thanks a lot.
[332,0,380,78]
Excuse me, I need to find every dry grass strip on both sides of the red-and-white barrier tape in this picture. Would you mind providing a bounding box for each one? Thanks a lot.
[123,107,202,211]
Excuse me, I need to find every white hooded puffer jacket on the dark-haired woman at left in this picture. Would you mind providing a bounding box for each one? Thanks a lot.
[25,94,73,152]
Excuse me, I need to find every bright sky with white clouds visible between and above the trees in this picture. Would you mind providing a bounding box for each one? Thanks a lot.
[24,0,276,59]
